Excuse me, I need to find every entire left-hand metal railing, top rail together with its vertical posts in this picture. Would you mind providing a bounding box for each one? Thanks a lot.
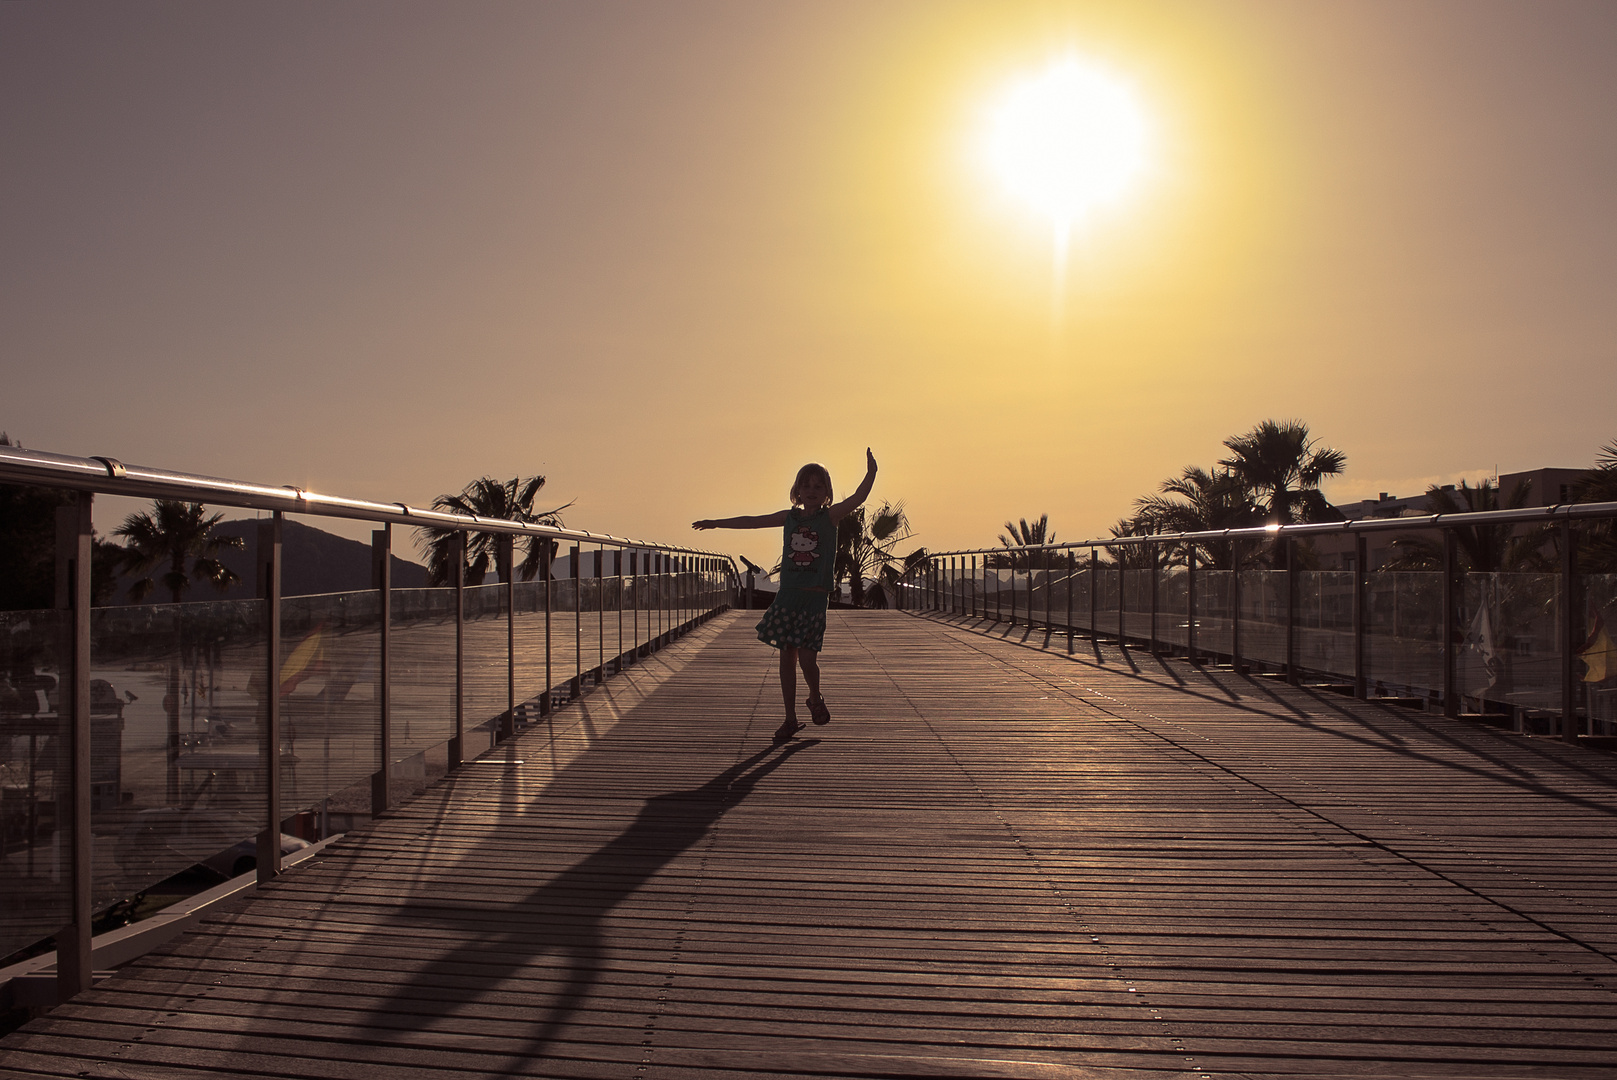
[0,446,742,999]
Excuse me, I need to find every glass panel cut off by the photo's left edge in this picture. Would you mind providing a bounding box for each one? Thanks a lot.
[0,611,69,956]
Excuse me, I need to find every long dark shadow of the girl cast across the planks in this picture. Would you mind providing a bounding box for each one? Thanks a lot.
[359,739,817,1059]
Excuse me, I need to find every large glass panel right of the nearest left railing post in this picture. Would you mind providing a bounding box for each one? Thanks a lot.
[91,600,265,909]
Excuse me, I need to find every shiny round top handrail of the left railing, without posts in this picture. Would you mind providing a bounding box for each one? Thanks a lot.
[0,446,739,556]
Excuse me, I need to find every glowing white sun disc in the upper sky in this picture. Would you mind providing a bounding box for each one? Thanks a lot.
[983,57,1150,234]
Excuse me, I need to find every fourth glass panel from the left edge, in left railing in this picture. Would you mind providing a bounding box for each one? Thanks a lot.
[388,589,454,761]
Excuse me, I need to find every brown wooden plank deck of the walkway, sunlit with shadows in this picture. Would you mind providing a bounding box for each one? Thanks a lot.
[0,613,1617,1080]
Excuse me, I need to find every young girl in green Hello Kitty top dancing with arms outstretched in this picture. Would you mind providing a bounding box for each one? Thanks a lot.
[690,448,876,745]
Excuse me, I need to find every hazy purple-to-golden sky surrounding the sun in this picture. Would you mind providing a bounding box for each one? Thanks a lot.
[0,0,1617,561]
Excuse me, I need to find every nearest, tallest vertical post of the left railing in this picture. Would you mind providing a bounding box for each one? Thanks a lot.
[57,491,95,1001]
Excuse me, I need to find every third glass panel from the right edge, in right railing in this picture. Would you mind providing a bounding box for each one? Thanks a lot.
[1349,571,1442,697]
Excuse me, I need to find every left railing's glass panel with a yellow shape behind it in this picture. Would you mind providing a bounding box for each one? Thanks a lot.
[281,590,382,815]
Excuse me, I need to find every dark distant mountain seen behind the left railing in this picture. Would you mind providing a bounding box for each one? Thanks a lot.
[113,519,427,603]
